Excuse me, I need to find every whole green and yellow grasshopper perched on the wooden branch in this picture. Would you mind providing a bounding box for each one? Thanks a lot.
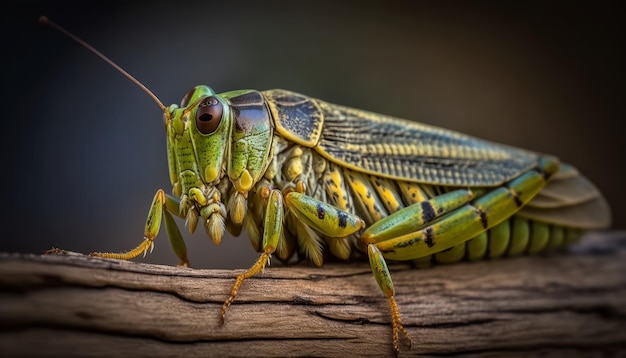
[42,18,610,355]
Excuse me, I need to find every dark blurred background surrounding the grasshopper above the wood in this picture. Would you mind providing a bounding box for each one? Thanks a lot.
[0,1,626,268]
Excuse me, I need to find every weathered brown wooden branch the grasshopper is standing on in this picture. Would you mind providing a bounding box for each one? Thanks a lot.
[0,232,626,358]
